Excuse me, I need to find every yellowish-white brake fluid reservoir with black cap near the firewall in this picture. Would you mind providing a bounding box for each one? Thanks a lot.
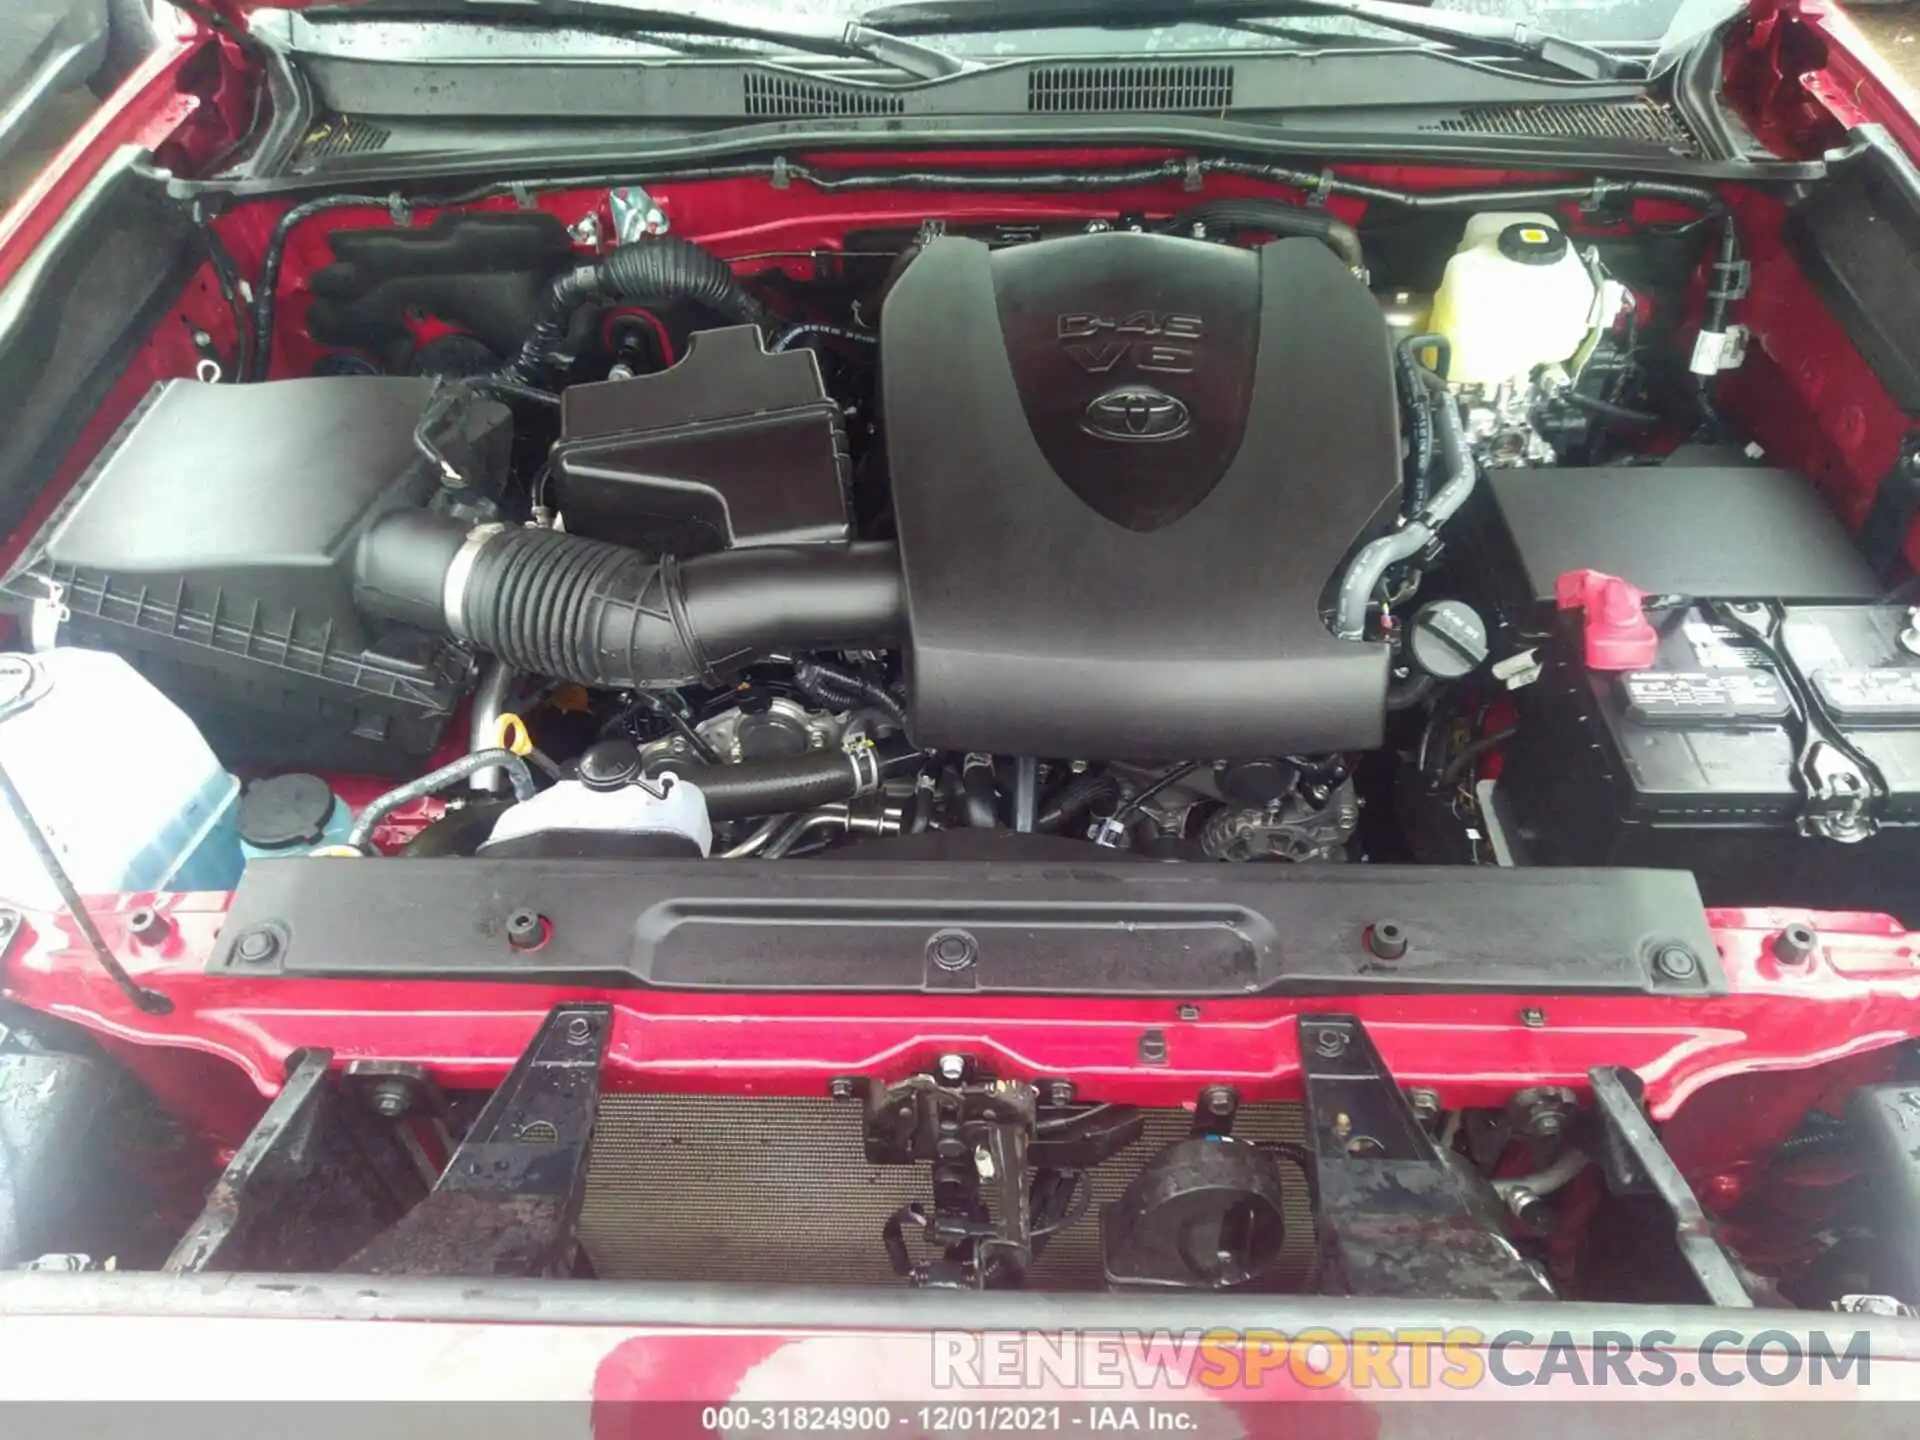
[1430,211,1594,386]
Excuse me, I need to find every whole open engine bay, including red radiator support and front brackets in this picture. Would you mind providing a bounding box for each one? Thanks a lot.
[0,144,1920,1309]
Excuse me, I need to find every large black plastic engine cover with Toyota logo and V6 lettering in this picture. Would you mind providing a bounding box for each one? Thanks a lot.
[881,232,1400,758]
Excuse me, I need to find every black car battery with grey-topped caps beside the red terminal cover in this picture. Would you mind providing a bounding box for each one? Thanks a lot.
[1490,603,1920,918]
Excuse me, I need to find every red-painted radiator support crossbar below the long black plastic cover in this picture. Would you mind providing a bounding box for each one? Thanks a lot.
[4,902,1920,1198]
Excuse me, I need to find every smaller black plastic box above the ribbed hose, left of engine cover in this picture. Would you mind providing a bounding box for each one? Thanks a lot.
[553,324,849,557]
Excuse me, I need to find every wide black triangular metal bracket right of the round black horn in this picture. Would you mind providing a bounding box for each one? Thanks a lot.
[1300,1016,1551,1300]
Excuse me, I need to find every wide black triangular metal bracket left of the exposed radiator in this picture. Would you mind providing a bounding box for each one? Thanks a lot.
[342,1004,612,1279]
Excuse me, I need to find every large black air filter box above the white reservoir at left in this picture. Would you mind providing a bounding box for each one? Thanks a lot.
[6,376,487,774]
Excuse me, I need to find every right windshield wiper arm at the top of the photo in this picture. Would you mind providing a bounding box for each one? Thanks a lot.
[860,0,1640,81]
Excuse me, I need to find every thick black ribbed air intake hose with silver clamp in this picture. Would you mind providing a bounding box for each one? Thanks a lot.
[353,511,906,689]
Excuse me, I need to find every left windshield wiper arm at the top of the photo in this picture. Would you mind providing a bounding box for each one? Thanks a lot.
[328,0,972,81]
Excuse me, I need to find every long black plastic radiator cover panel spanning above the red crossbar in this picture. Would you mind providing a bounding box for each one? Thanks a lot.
[211,858,1724,998]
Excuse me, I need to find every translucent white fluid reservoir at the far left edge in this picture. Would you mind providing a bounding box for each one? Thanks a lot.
[0,649,242,910]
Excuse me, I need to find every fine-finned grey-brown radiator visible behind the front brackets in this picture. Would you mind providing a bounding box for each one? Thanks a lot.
[580,1094,1313,1290]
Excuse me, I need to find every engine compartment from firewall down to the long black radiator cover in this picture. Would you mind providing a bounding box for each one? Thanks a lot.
[8,167,1920,910]
